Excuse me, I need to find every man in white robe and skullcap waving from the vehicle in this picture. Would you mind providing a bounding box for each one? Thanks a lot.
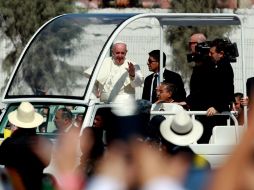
[85,41,144,102]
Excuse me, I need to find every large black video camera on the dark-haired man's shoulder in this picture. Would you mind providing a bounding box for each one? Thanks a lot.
[187,38,239,62]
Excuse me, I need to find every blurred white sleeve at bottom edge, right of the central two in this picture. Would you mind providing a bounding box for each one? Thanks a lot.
[141,177,186,190]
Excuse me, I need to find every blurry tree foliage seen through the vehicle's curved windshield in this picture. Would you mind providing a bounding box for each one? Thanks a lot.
[17,18,83,94]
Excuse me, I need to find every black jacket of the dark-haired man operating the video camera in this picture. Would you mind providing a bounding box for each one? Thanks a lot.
[187,59,234,112]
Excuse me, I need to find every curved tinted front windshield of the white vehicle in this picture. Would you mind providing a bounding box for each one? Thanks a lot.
[5,14,135,99]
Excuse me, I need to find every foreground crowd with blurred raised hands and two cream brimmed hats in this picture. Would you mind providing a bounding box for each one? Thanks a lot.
[0,100,254,190]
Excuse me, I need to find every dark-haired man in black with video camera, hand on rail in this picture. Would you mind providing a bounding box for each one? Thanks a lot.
[188,35,234,143]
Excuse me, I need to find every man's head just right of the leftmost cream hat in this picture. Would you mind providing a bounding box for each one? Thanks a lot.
[54,108,72,131]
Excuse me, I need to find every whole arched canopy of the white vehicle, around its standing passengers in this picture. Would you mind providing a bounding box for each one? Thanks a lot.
[4,13,245,106]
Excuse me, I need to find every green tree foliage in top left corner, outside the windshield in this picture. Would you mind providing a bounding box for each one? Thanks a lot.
[0,0,74,71]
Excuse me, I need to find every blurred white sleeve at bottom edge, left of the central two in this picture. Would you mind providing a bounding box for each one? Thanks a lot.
[86,176,127,190]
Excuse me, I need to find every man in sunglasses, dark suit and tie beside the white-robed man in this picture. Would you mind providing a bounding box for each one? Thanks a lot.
[142,50,186,103]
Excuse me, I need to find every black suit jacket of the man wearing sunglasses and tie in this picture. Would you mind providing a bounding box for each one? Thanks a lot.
[142,69,186,103]
